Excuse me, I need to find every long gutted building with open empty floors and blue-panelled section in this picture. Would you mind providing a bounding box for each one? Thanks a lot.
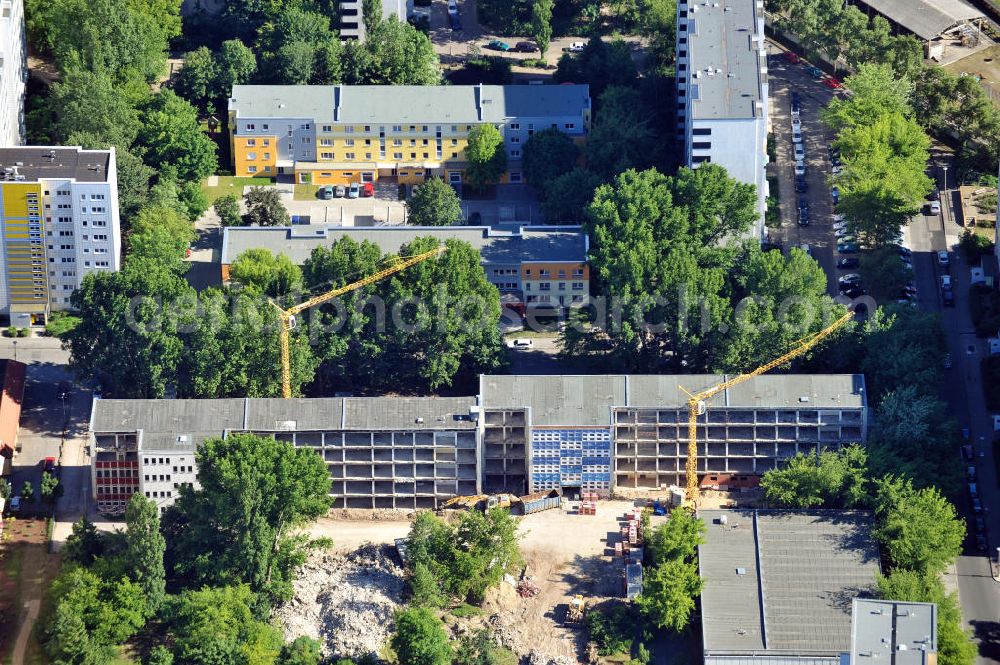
[90,375,867,513]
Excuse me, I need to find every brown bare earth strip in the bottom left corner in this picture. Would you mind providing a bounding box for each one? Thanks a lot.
[0,519,59,665]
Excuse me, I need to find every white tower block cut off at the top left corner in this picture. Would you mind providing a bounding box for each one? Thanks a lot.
[0,0,28,147]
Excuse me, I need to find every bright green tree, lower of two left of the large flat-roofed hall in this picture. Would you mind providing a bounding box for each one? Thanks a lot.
[637,559,704,632]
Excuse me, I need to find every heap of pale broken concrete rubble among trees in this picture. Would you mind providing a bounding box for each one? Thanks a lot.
[276,545,406,658]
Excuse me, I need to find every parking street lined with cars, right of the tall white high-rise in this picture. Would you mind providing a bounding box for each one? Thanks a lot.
[768,42,844,296]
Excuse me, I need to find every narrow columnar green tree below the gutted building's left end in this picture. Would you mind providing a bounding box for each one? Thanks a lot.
[125,494,166,614]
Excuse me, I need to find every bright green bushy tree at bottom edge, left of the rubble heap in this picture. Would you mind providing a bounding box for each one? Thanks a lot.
[169,584,282,665]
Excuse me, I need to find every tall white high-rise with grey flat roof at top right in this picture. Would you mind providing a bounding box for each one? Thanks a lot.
[677,0,768,239]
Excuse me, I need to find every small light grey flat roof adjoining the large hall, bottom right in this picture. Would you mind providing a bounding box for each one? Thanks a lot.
[851,598,937,665]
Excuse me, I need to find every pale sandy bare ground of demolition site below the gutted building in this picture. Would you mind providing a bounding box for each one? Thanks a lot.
[311,501,658,663]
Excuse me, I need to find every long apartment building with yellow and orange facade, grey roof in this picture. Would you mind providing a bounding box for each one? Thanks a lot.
[229,85,591,185]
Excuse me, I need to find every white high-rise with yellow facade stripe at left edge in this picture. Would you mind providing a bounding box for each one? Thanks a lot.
[0,146,121,327]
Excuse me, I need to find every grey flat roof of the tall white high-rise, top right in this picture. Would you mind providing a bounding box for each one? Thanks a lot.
[678,0,767,120]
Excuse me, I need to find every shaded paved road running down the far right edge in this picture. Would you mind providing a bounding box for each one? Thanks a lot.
[906,166,1000,663]
